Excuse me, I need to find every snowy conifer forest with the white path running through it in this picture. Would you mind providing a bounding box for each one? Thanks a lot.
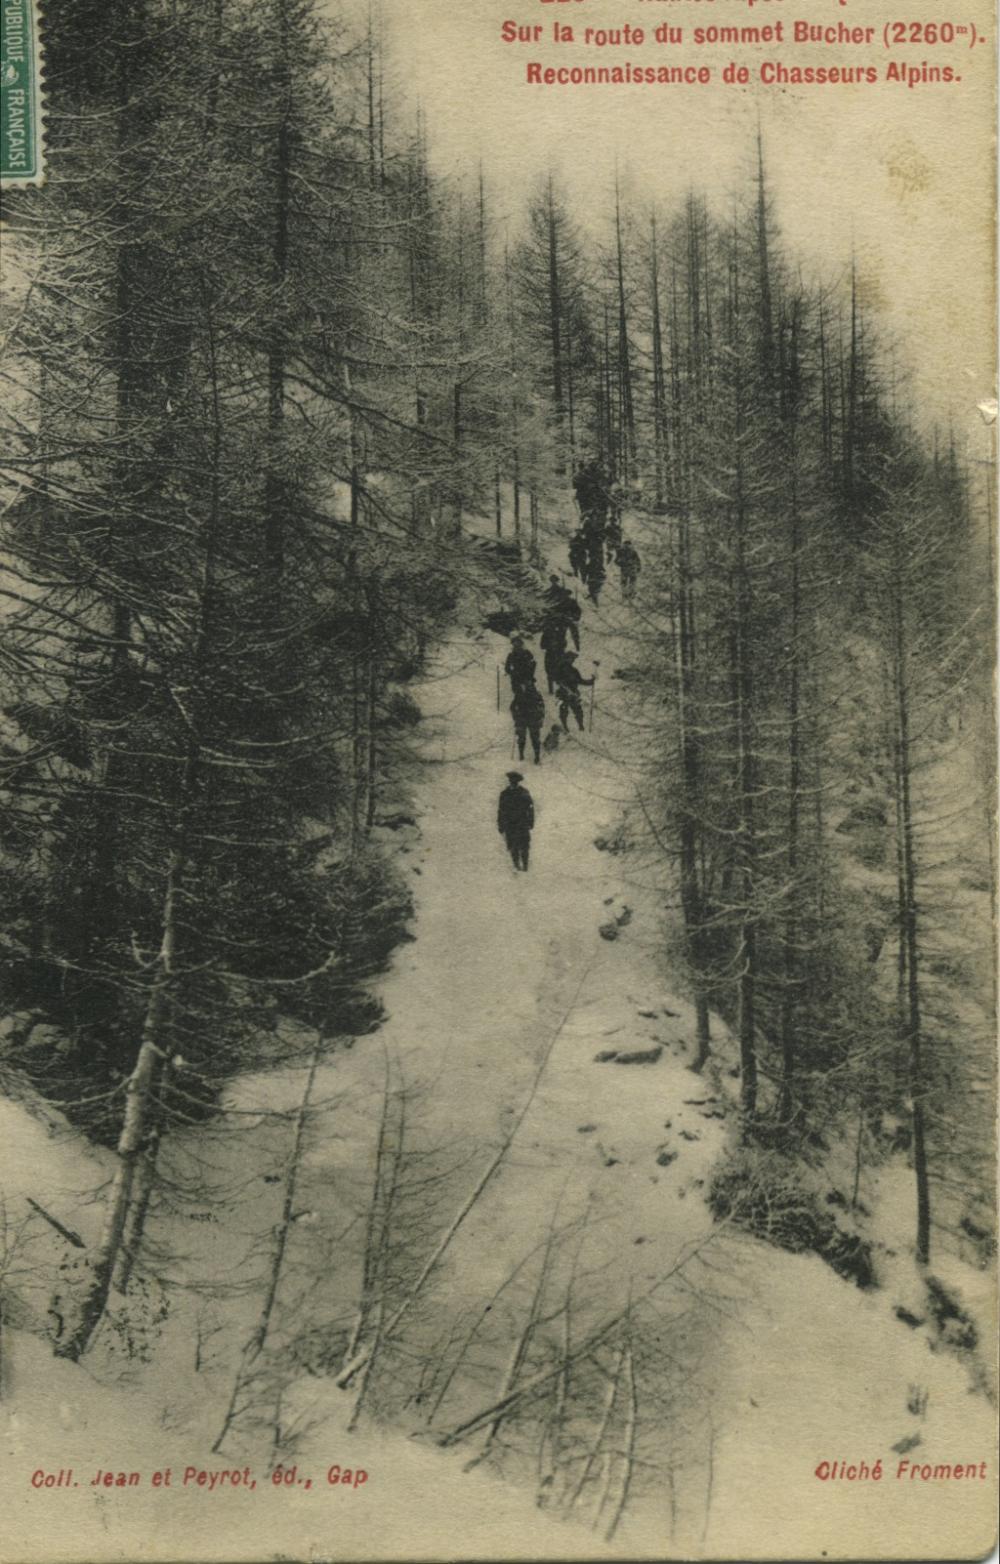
[0,0,995,1556]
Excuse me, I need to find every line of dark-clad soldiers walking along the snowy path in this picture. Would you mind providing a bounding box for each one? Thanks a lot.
[496,460,640,871]
